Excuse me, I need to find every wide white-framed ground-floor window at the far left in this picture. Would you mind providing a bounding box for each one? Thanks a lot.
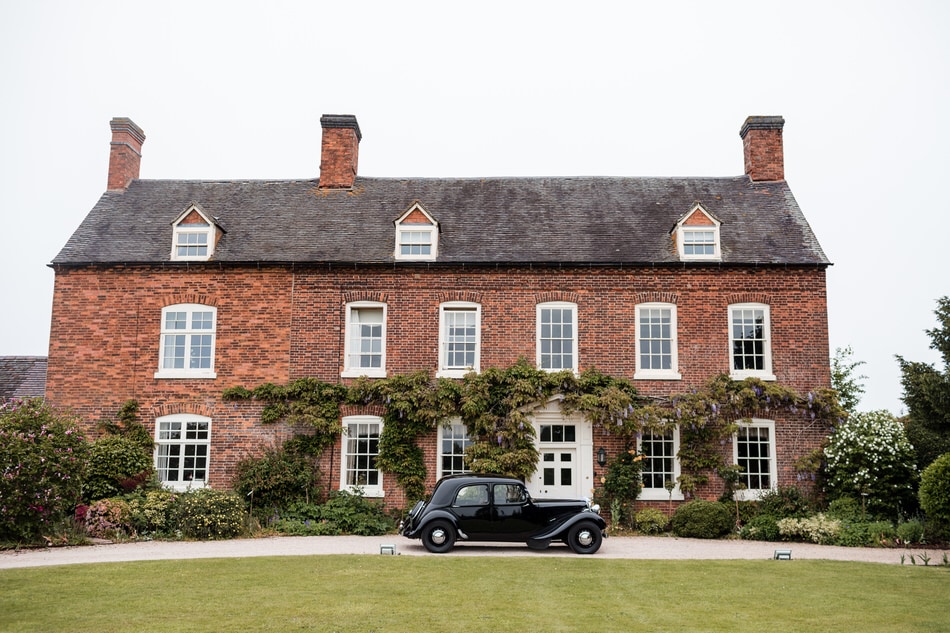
[153,413,211,491]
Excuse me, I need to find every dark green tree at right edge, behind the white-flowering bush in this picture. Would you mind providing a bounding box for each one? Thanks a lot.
[897,297,950,469]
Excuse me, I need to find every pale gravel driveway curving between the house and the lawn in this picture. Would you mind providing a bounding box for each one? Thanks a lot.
[0,536,950,569]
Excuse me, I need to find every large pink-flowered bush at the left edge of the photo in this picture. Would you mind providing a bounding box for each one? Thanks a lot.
[0,399,89,541]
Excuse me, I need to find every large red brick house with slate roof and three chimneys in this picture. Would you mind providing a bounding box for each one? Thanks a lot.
[46,115,830,506]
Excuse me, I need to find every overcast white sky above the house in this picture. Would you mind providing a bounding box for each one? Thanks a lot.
[0,0,950,414]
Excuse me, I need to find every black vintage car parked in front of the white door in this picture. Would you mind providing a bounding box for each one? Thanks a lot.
[399,475,607,554]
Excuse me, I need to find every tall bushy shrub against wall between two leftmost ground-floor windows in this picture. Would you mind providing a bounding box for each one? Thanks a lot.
[234,441,318,514]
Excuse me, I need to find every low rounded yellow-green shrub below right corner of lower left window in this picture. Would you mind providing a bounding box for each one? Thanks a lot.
[176,488,247,539]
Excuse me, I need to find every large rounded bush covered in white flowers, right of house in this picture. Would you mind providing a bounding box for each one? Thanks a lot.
[825,411,916,518]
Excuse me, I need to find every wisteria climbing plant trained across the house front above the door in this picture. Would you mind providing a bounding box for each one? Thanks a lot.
[223,366,845,501]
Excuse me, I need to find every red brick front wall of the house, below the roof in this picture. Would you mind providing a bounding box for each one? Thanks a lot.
[47,265,830,499]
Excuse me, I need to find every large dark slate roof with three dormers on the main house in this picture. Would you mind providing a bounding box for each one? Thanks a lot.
[53,176,830,266]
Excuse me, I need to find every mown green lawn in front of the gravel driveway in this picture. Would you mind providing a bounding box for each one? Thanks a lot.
[0,555,950,633]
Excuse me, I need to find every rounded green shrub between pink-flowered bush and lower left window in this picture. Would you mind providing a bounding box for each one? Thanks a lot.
[83,435,153,501]
